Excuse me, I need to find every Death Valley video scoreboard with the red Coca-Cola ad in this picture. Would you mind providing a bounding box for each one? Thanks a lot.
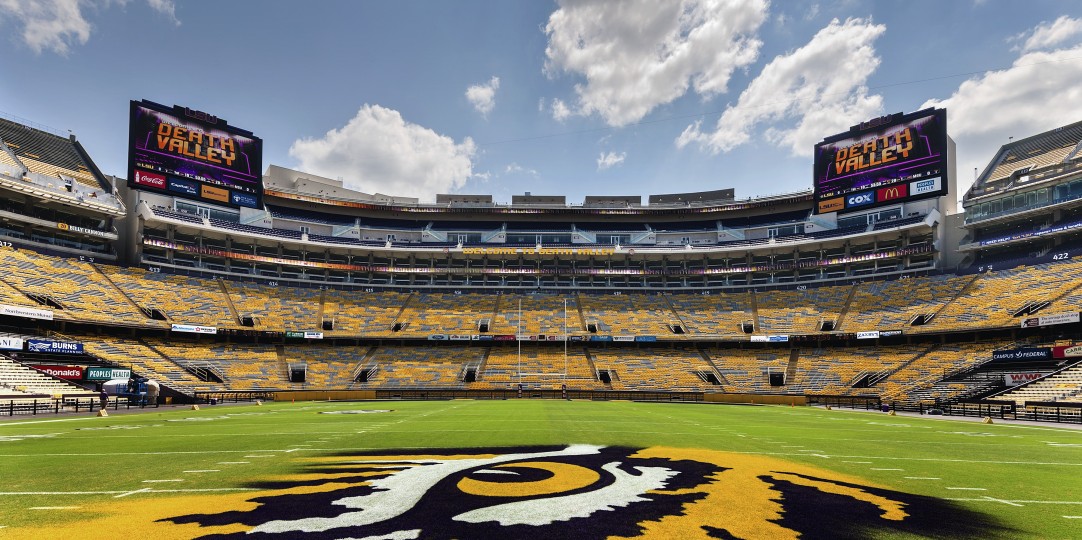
[128,100,263,208]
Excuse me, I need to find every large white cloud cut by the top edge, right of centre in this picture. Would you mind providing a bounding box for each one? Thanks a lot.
[544,0,767,127]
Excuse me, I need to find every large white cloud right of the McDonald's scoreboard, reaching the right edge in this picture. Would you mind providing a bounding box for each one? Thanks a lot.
[922,45,1082,195]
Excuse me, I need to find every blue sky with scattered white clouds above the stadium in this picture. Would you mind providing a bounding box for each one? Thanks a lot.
[0,0,1082,202]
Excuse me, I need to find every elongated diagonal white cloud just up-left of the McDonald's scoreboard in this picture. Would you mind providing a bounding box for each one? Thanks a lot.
[676,18,886,156]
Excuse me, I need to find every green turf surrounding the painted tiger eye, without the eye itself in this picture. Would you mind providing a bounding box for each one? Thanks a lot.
[0,399,1082,538]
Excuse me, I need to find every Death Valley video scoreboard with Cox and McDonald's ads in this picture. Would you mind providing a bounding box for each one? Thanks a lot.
[814,109,947,213]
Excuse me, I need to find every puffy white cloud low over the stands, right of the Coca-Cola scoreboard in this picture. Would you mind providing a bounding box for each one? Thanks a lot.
[289,104,476,200]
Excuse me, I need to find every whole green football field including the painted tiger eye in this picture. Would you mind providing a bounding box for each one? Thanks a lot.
[0,400,1082,539]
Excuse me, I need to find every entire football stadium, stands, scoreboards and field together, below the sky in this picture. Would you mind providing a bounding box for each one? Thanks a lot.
[0,101,1082,538]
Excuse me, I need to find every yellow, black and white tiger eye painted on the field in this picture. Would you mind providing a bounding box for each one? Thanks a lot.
[158,445,1006,540]
